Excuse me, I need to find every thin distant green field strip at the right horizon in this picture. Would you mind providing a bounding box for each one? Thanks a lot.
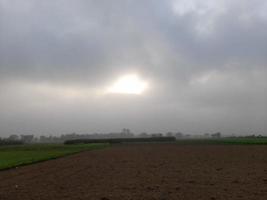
[176,137,267,145]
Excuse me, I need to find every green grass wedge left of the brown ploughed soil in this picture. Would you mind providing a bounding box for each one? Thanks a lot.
[0,144,109,170]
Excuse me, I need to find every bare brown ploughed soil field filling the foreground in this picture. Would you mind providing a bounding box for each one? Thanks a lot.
[0,144,267,200]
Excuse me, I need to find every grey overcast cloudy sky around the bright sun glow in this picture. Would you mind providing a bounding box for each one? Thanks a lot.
[0,0,267,137]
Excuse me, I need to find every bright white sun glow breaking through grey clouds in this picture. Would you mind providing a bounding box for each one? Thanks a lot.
[107,74,148,95]
